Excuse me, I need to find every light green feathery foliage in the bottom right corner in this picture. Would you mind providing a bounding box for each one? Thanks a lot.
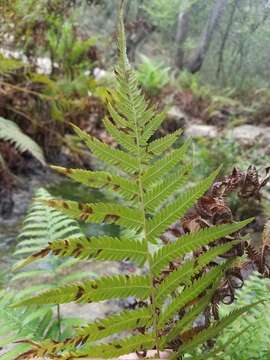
[207,273,270,360]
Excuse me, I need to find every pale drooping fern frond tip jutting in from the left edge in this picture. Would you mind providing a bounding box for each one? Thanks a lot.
[0,117,46,165]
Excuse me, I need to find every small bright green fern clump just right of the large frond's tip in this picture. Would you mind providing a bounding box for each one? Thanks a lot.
[137,55,170,95]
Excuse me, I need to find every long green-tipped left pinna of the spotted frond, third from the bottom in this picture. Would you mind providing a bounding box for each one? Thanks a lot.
[13,275,150,307]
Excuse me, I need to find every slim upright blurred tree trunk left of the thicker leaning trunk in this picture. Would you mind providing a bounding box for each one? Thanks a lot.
[175,9,190,69]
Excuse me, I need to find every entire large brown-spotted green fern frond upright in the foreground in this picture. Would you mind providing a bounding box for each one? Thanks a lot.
[11,3,258,359]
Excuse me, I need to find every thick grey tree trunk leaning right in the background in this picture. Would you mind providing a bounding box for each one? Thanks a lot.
[186,0,228,73]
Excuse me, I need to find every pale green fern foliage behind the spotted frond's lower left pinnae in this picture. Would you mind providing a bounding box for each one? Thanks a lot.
[0,189,91,360]
